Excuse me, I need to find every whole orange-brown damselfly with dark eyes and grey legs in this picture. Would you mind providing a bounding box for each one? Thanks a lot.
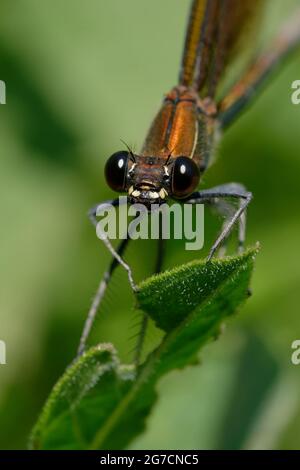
[79,0,300,354]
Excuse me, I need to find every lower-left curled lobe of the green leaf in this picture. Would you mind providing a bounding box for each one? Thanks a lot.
[29,344,134,449]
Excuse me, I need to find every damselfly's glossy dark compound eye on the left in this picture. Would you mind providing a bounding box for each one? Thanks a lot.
[104,151,129,192]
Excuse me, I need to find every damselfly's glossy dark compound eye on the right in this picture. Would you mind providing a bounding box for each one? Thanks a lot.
[172,157,200,199]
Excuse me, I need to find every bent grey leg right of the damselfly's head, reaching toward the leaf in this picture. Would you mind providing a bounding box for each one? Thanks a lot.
[186,183,252,261]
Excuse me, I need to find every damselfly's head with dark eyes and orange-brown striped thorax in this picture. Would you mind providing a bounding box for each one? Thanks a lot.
[105,86,216,205]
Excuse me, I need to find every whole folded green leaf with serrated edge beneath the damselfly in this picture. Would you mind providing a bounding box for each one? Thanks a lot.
[30,249,257,449]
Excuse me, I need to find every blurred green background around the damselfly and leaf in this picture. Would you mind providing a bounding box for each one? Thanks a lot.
[0,0,300,449]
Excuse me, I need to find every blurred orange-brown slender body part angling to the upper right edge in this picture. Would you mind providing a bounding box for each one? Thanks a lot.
[218,9,300,129]
